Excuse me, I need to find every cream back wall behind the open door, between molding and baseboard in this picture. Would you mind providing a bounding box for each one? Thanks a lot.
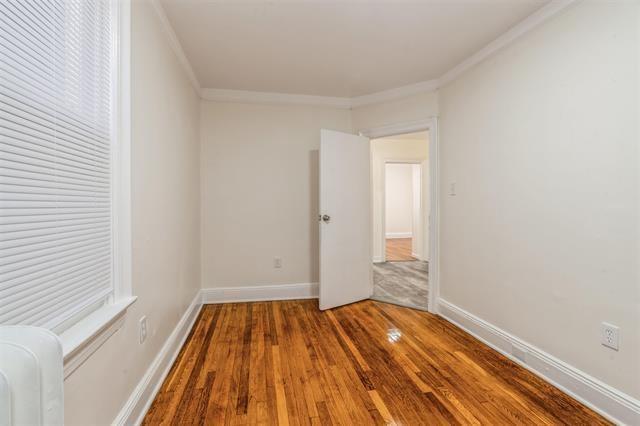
[201,101,351,288]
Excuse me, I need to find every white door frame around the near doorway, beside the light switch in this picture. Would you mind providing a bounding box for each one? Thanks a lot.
[358,116,440,314]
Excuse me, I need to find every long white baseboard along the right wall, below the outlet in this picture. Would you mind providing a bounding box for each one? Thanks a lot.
[438,299,640,425]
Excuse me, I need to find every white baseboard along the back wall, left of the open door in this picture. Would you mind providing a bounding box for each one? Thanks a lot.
[202,283,318,303]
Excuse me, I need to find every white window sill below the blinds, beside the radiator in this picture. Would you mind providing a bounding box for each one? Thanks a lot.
[60,296,137,379]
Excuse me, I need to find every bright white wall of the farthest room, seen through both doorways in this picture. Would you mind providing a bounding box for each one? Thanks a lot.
[385,163,413,238]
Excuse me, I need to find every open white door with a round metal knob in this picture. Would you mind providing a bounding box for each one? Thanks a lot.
[320,129,373,310]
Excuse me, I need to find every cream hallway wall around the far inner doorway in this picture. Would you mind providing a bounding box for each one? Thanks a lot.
[371,138,429,262]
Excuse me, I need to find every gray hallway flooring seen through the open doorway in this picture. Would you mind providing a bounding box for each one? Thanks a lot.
[373,261,429,309]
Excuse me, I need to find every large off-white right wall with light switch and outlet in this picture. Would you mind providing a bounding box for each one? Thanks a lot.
[440,1,640,398]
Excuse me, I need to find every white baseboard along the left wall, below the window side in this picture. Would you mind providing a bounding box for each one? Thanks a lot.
[112,292,202,426]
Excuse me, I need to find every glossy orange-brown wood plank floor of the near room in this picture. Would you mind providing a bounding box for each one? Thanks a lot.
[144,300,607,425]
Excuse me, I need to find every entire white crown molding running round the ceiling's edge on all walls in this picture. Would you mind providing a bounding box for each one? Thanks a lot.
[159,0,580,109]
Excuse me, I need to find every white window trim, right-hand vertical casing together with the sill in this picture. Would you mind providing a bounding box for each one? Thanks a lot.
[59,0,137,379]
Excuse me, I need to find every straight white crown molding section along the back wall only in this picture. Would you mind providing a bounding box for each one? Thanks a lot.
[200,89,351,109]
